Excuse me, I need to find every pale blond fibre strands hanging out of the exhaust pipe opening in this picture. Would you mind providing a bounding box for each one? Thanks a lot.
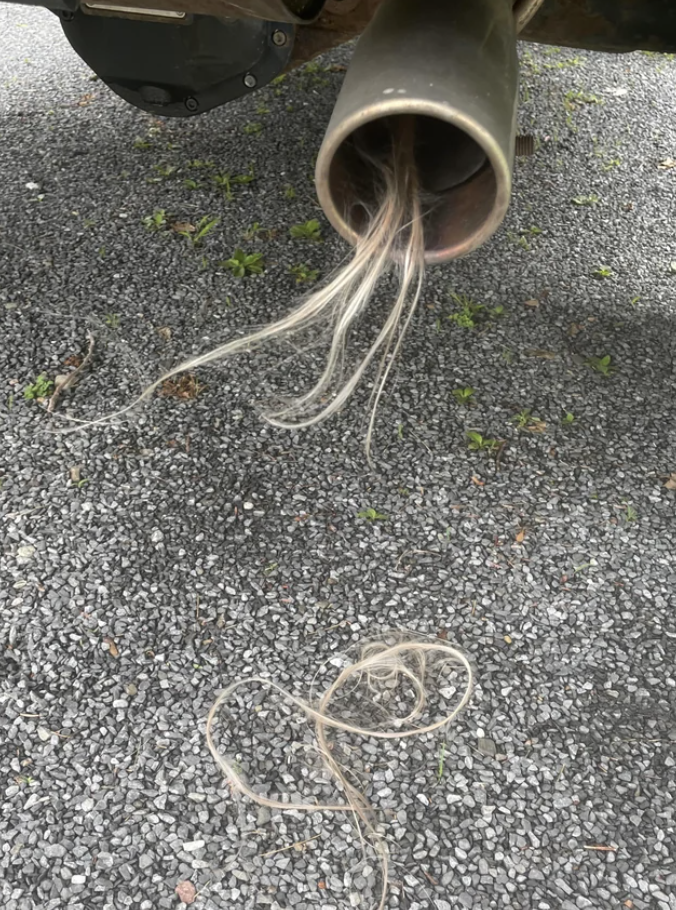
[71,117,425,466]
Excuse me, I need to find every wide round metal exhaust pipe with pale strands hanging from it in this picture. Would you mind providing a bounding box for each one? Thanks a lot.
[315,0,518,263]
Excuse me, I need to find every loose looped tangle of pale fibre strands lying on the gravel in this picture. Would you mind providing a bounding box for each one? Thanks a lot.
[206,633,473,910]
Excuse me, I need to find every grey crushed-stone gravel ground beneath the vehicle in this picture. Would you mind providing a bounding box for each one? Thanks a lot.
[0,6,676,910]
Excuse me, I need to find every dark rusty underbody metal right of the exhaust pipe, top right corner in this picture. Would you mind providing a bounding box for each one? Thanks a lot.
[521,0,676,52]
